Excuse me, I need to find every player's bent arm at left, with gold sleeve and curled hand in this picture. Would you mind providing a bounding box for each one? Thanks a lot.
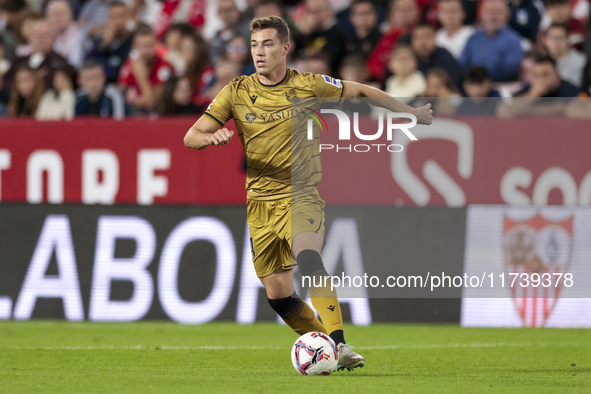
[184,84,234,150]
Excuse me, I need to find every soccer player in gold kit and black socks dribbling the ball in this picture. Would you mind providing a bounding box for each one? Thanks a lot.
[184,16,433,370]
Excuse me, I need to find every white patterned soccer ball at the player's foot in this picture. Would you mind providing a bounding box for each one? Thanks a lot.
[291,331,339,375]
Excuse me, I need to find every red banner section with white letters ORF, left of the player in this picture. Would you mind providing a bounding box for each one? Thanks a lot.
[0,118,246,205]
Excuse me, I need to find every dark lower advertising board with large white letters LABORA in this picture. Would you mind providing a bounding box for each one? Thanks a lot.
[0,203,465,325]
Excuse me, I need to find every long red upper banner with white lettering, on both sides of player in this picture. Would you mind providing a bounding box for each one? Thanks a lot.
[0,116,591,206]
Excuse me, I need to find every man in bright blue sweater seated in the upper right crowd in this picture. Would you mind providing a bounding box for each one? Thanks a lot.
[460,0,523,82]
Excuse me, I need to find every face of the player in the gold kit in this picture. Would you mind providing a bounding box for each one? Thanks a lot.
[250,29,289,75]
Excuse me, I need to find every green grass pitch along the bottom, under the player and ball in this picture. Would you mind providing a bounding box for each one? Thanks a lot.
[0,321,591,394]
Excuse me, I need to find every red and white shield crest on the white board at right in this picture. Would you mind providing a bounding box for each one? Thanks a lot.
[503,213,573,327]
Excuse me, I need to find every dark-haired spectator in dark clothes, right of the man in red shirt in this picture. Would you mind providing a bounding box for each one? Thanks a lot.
[158,76,201,116]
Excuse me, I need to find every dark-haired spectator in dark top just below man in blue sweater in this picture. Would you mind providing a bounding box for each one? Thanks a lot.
[456,66,501,115]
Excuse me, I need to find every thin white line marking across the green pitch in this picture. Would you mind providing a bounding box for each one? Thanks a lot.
[5,343,545,350]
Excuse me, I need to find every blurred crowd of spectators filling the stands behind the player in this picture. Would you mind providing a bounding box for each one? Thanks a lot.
[0,0,591,119]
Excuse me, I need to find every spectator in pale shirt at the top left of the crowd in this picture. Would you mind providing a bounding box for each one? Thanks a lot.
[47,0,86,69]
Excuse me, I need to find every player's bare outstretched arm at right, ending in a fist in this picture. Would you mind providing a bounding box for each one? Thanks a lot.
[343,81,433,124]
